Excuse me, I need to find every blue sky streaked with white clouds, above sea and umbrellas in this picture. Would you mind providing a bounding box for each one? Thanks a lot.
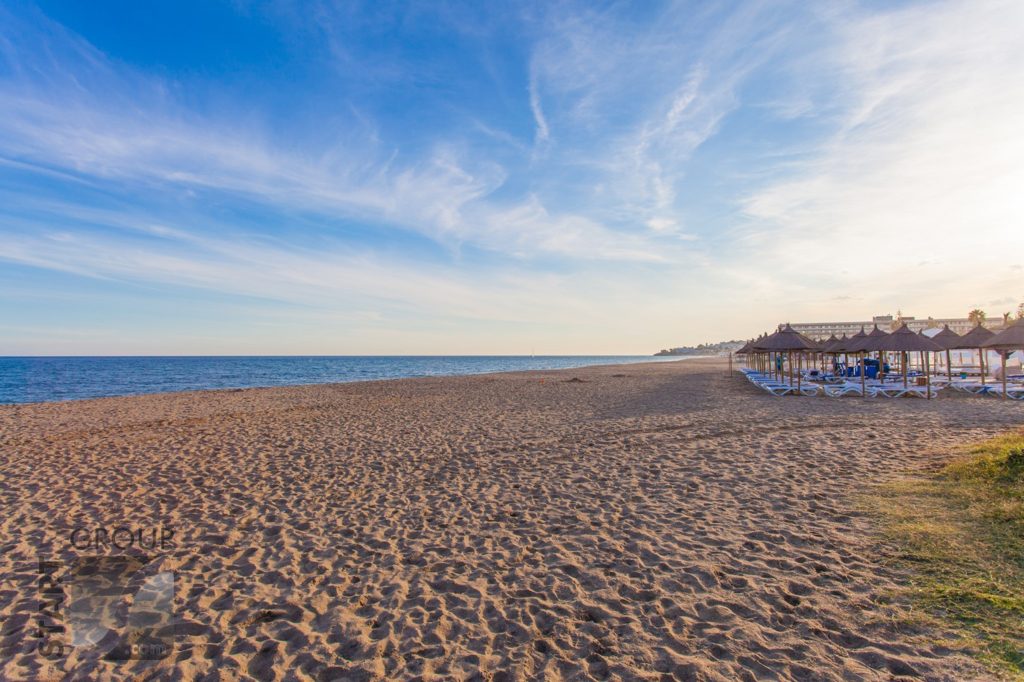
[0,0,1024,355]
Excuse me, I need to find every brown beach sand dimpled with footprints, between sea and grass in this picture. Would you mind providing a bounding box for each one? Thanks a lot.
[0,359,1024,680]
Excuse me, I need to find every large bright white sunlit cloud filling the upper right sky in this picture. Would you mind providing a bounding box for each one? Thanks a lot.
[744,2,1024,309]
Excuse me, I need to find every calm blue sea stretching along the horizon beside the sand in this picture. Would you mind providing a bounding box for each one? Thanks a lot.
[0,355,679,403]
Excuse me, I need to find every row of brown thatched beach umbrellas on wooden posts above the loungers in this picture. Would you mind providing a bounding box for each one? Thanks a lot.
[736,319,1024,398]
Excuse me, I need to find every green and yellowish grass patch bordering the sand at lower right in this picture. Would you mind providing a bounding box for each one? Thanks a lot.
[869,431,1024,680]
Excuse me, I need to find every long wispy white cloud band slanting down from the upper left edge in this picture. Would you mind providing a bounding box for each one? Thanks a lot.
[0,7,655,259]
